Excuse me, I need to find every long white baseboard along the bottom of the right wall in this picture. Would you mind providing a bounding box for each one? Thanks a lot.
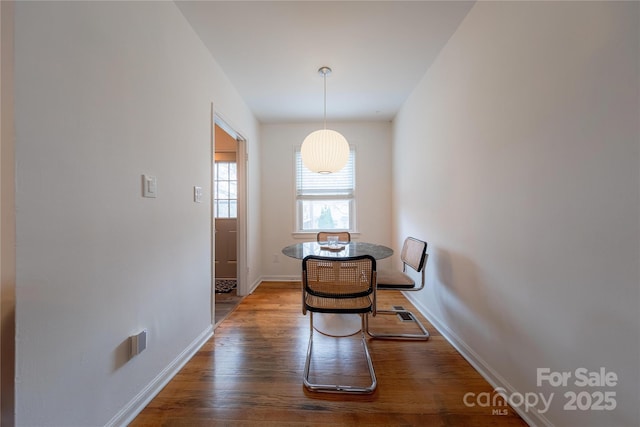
[403,292,553,427]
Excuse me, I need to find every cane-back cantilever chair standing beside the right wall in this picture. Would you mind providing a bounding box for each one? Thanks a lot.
[365,237,429,340]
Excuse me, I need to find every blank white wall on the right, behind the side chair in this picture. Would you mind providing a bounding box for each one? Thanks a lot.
[393,2,640,426]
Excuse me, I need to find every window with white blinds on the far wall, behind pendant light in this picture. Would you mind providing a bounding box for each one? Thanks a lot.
[296,148,355,232]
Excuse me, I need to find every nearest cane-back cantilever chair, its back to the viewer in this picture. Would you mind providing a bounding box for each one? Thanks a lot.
[302,255,377,394]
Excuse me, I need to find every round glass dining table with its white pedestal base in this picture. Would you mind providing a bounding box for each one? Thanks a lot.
[282,242,393,337]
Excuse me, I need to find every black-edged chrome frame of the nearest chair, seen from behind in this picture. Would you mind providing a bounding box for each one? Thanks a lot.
[302,255,378,394]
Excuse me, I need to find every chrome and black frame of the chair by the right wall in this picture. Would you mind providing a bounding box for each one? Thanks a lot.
[364,237,430,341]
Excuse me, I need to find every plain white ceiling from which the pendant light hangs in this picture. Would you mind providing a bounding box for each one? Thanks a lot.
[176,1,473,123]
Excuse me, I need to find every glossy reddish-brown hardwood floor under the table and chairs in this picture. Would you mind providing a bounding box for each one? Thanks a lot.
[131,282,526,427]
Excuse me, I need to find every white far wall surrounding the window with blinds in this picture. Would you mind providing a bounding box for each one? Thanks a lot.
[260,122,391,280]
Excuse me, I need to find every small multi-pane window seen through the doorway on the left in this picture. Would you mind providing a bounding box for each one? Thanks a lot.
[213,162,238,218]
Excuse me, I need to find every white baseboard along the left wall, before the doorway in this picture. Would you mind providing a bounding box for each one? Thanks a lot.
[105,325,213,427]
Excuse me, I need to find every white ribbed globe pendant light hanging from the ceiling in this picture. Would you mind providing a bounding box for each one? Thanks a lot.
[300,67,349,174]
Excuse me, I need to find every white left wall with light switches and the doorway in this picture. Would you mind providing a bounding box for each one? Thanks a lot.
[15,2,260,426]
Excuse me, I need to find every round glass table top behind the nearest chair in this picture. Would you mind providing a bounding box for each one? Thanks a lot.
[282,242,393,259]
